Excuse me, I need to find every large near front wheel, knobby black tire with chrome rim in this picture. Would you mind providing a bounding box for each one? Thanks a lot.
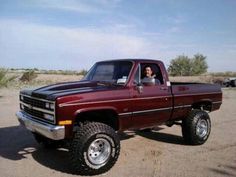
[70,122,120,175]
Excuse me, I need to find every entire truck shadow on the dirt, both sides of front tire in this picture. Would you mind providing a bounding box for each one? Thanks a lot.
[0,126,183,174]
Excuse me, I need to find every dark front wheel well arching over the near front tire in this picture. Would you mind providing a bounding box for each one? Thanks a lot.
[75,110,119,130]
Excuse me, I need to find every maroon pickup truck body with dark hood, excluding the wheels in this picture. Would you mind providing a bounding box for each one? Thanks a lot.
[17,59,222,175]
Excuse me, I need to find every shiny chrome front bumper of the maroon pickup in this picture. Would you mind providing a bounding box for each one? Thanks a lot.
[16,111,65,140]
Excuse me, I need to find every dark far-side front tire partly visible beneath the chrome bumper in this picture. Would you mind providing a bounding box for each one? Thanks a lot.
[33,133,62,149]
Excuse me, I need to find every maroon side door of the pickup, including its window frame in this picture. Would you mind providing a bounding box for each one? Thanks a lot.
[132,63,172,128]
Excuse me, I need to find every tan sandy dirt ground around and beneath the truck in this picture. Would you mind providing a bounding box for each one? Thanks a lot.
[0,89,236,177]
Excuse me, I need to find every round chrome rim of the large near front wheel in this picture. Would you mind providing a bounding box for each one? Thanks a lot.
[87,138,111,165]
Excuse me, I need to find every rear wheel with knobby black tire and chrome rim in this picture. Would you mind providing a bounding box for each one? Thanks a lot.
[182,110,211,145]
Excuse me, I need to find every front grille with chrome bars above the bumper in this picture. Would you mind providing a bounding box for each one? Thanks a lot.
[20,94,55,124]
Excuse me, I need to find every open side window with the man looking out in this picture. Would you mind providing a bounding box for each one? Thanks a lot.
[141,63,163,86]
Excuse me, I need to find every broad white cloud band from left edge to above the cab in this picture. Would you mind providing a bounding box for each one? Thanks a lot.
[0,20,159,69]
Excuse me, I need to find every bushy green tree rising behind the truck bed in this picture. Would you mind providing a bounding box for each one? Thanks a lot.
[168,54,208,76]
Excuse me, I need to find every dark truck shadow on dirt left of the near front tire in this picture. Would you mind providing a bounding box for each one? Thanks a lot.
[0,126,73,174]
